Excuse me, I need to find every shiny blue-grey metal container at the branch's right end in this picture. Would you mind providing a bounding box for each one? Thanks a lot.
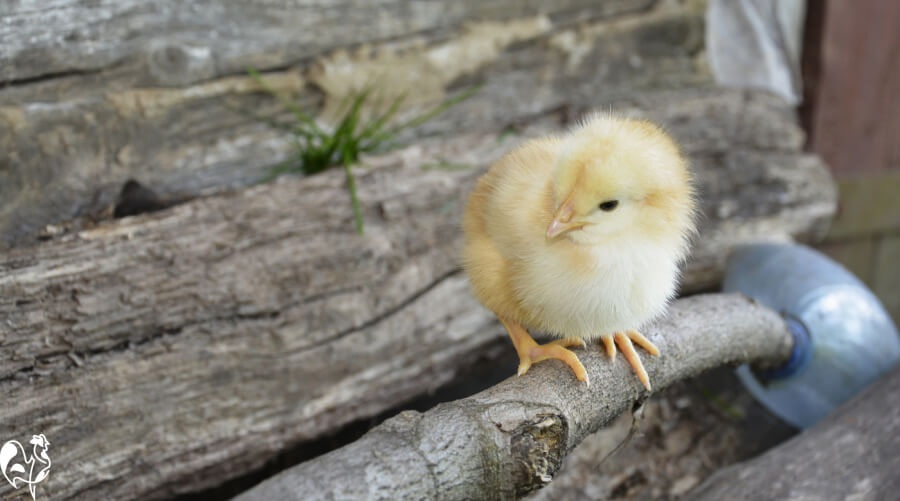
[722,243,900,428]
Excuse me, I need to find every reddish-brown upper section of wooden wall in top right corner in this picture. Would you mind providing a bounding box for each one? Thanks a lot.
[807,0,900,175]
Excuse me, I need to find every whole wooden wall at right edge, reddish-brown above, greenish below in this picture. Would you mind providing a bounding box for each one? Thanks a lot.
[802,0,900,323]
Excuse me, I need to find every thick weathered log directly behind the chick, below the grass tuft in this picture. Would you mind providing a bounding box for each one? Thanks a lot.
[0,91,834,499]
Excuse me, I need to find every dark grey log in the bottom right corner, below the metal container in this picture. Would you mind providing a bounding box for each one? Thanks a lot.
[688,367,900,501]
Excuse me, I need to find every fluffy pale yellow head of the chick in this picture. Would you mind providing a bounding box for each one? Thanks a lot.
[546,115,694,247]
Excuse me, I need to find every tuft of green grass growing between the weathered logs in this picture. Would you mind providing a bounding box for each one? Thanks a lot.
[247,68,480,235]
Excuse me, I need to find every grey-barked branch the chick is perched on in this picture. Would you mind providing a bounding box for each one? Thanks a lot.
[237,294,791,501]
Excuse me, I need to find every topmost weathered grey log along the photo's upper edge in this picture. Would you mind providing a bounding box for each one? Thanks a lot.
[0,0,654,87]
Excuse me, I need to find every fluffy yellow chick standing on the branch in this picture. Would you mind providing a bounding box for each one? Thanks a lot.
[463,114,695,390]
